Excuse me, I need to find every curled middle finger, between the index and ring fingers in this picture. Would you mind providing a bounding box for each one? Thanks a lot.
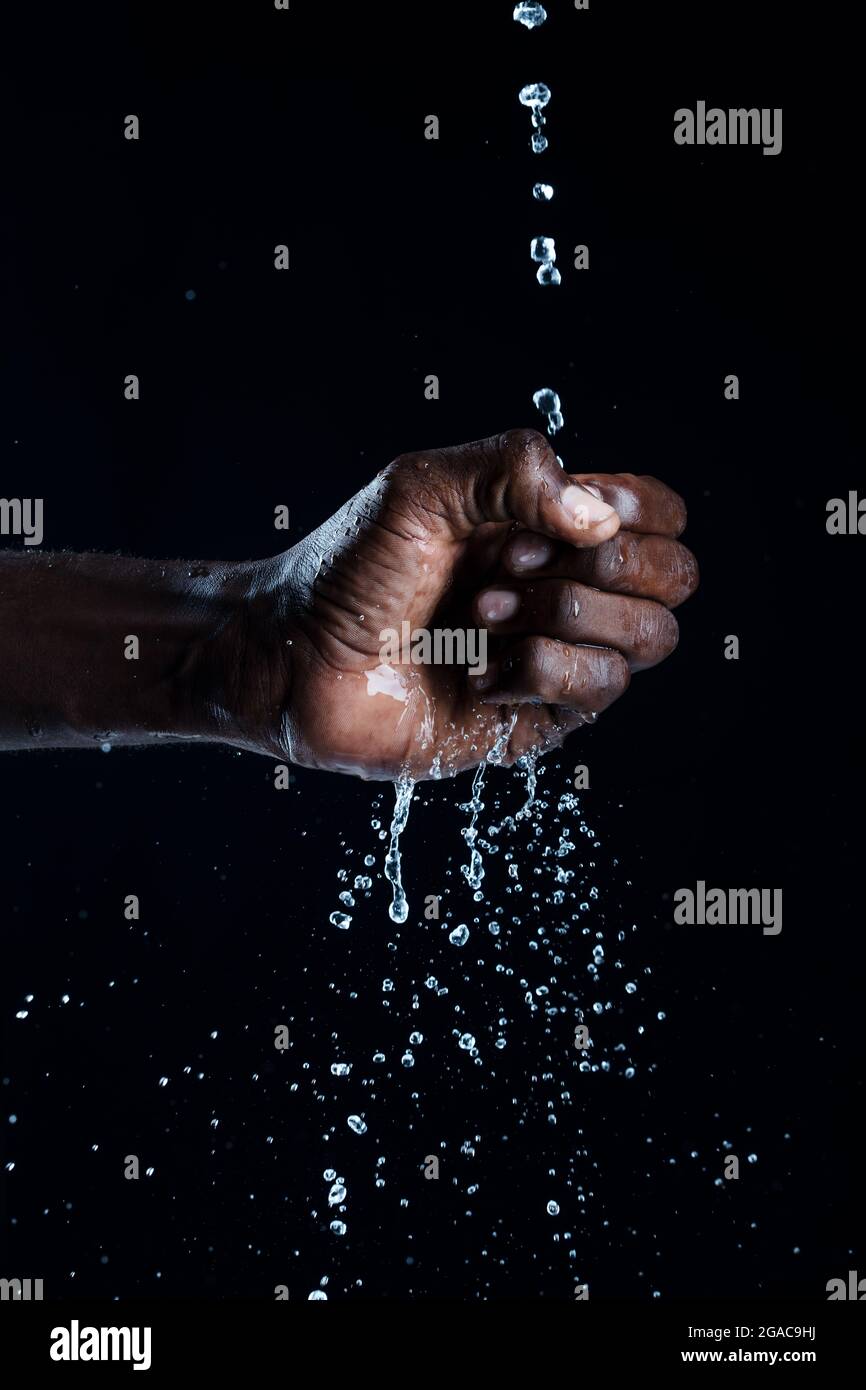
[502,531,699,607]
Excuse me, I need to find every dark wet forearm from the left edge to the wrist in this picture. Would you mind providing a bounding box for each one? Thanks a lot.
[0,550,261,749]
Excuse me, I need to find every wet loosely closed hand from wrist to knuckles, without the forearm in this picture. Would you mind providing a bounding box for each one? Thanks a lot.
[246,430,698,778]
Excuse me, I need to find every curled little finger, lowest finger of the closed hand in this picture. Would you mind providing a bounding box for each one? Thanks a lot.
[470,635,630,714]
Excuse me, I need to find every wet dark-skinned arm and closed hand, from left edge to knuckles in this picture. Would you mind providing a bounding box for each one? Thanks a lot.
[0,430,698,778]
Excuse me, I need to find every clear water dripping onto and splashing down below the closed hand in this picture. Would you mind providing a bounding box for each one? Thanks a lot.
[273,29,686,1297]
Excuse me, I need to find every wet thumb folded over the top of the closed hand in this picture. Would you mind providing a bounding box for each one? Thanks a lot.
[392,430,620,546]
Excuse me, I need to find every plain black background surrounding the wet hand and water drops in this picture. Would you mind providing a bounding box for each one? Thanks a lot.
[0,0,866,1300]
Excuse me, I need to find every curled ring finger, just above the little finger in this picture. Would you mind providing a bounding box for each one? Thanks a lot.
[473,580,680,671]
